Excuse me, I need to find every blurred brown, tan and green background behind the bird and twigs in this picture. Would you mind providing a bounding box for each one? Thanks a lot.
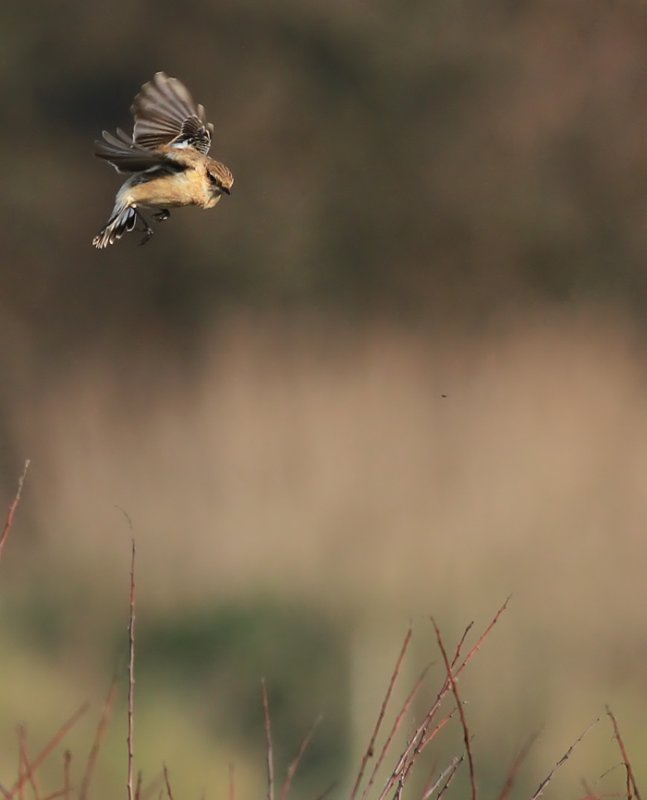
[0,0,647,800]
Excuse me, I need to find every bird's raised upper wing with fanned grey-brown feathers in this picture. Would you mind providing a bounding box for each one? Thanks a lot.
[130,72,213,155]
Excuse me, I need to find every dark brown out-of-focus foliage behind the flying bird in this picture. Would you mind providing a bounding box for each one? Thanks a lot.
[0,0,647,354]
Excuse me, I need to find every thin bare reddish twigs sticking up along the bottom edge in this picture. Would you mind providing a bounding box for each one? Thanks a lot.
[0,461,641,800]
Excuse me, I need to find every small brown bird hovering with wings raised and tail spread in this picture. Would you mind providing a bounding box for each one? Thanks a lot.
[92,72,234,249]
